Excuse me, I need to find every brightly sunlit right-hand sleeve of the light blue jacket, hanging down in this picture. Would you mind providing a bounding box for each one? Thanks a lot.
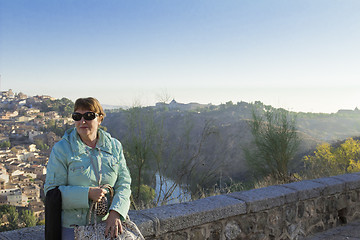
[110,139,131,221]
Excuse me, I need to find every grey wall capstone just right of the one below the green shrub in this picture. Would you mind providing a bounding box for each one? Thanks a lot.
[282,180,326,201]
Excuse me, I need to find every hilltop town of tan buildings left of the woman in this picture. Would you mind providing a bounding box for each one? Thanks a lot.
[0,90,72,224]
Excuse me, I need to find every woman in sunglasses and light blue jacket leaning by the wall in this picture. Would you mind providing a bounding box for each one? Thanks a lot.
[44,97,131,239]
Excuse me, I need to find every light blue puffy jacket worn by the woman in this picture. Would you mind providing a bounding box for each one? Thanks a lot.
[44,128,131,227]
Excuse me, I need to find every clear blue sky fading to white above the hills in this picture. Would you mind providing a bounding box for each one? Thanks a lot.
[0,0,360,113]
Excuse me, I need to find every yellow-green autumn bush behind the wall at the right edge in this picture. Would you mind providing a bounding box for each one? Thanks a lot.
[304,138,360,178]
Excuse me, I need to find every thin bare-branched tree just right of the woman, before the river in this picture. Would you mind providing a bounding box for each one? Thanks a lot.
[124,104,220,206]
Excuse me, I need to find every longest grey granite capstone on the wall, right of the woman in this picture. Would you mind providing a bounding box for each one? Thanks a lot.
[139,195,246,234]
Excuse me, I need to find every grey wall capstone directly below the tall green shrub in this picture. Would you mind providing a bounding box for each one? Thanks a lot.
[228,185,297,212]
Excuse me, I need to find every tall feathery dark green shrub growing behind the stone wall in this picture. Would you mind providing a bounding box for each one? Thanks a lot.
[244,108,300,182]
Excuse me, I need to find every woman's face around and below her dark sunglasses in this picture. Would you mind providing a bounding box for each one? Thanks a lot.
[75,109,100,140]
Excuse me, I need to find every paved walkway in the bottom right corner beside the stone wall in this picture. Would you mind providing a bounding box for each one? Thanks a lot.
[305,221,360,240]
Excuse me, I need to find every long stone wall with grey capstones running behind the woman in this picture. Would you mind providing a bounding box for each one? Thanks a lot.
[0,173,360,240]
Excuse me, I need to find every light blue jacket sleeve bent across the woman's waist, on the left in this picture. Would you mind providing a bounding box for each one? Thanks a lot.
[44,141,89,209]
